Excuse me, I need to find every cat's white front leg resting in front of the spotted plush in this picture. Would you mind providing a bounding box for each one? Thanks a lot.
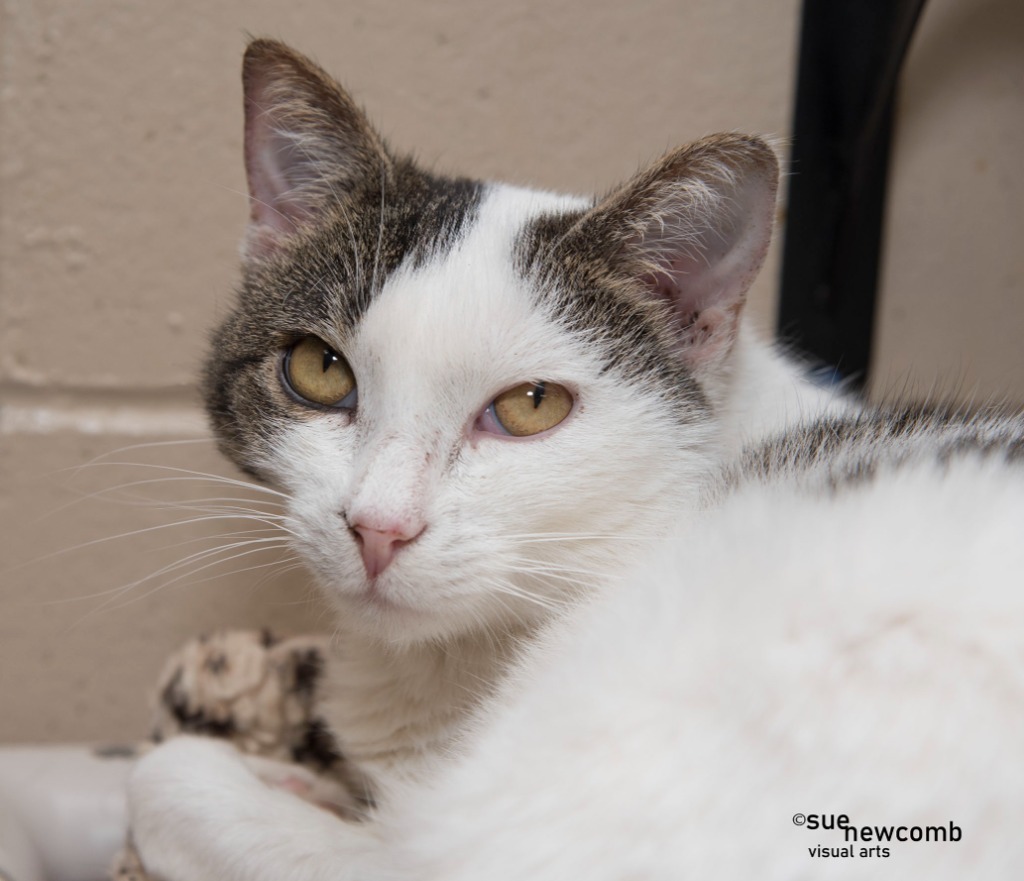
[128,737,375,881]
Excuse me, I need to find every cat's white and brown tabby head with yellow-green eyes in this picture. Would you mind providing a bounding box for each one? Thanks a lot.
[206,40,777,642]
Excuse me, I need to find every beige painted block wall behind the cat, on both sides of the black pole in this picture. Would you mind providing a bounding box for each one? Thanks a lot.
[0,0,1024,741]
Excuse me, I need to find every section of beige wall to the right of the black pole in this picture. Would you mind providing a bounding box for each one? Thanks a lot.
[871,0,1024,403]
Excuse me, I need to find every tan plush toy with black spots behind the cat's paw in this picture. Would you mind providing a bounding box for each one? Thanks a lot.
[113,630,368,881]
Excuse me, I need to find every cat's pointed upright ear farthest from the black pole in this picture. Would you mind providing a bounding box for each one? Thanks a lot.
[242,40,390,259]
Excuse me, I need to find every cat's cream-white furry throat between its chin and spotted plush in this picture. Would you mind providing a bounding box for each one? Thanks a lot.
[321,628,530,784]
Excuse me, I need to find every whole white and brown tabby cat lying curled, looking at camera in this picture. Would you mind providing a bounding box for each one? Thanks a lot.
[131,40,1024,881]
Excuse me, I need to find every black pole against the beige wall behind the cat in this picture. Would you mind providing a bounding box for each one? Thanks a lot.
[778,0,925,383]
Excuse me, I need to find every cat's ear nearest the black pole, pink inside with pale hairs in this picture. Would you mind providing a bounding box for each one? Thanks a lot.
[583,134,778,372]
